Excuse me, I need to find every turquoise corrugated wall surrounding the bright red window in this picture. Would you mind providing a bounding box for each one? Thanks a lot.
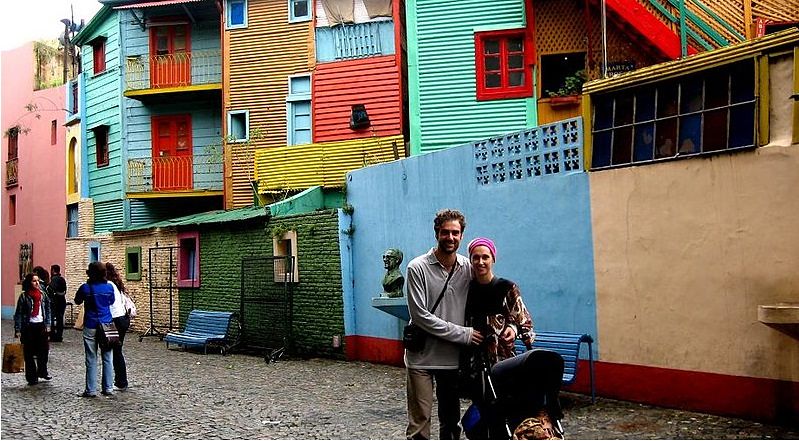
[406,0,537,155]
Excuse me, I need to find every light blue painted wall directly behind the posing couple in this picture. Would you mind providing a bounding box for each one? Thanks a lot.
[342,124,596,350]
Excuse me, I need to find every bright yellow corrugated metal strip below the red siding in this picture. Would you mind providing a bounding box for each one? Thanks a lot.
[255,135,404,191]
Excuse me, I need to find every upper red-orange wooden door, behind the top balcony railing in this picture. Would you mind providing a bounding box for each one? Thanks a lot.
[150,25,191,88]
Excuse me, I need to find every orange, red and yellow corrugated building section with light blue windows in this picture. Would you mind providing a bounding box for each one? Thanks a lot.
[223,0,407,207]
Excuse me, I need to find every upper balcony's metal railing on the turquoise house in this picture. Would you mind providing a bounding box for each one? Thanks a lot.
[125,50,222,90]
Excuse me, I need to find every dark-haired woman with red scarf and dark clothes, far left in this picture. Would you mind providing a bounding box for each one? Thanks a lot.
[14,273,52,386]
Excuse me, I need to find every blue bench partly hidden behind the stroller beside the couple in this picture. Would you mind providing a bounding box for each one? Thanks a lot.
[516,331,596,403]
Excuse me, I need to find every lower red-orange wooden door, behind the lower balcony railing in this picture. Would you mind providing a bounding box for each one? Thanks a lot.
[152,115,194,191]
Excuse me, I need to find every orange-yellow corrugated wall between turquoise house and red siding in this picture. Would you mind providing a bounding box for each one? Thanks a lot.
[224,0,315,208]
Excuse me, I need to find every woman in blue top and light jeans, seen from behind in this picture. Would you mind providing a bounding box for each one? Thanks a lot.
[75,262,115,398]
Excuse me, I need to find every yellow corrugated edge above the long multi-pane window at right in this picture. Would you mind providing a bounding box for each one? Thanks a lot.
[583,29,799,93]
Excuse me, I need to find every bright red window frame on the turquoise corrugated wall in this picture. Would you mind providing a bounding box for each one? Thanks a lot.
[474,28,533,101]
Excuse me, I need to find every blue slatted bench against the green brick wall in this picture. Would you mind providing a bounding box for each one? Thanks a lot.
[164,309,241,355]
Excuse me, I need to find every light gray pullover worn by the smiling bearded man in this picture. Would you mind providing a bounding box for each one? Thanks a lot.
[405,248,472,369]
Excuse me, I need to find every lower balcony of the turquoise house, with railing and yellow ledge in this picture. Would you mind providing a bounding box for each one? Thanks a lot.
[127,154,223,197]
